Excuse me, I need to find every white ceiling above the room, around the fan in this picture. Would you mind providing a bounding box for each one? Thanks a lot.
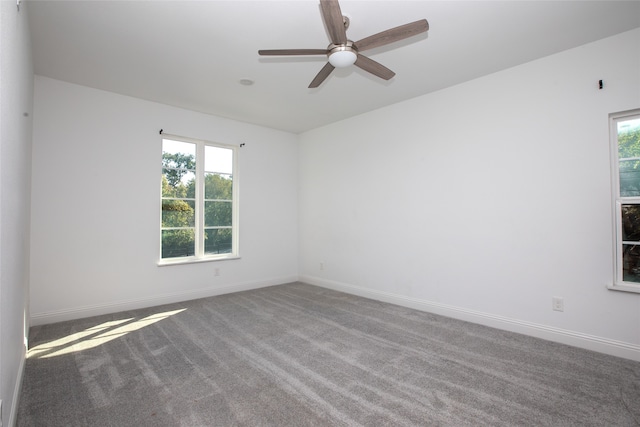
[27,0,640,133]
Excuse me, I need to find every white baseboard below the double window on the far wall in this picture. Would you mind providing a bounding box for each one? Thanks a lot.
[31,276,298,326]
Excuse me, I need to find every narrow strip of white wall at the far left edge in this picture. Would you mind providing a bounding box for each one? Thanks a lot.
[0,1,33,426]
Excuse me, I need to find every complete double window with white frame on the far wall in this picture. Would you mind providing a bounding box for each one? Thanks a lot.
[160,135,238,264]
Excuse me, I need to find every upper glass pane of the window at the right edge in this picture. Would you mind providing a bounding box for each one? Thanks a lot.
[618,119,640,197]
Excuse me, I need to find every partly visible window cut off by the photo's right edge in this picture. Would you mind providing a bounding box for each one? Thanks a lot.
[610,110,640,292]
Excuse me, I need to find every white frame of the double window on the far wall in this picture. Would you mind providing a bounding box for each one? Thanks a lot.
[158,133,240,266]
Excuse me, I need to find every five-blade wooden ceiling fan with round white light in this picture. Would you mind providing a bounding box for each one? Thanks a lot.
[258,0,429,88]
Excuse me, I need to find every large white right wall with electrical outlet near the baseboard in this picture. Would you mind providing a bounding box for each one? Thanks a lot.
[299,29,640,360]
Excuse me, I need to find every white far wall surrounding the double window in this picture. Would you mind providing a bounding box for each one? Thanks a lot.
[31,76,298,324]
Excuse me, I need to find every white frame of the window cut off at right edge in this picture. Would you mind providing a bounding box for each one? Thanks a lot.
[607,109,640,293]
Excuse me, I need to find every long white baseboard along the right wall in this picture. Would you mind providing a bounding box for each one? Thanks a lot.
[299,276,640,362]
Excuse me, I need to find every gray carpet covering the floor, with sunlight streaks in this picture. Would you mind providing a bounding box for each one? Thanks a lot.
[18,283,640,426]
